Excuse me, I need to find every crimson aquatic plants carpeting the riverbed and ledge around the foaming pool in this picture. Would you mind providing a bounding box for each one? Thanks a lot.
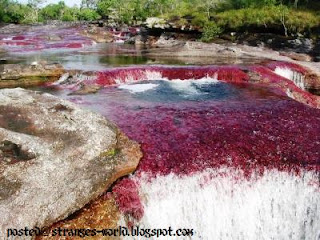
[63,65,320,223]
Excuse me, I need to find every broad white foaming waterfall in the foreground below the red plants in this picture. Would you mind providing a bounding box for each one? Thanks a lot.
[120,170,320,240]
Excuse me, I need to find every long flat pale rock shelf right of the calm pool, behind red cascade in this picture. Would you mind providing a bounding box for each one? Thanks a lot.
[147,38,320,87]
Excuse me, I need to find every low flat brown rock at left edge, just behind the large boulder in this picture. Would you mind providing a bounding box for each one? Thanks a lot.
[0,62,64,88]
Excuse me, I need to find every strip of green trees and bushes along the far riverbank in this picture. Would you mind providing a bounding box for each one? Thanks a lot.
[0,0,320,39]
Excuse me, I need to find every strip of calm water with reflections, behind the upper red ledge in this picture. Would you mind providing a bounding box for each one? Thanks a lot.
[0,43,264,71]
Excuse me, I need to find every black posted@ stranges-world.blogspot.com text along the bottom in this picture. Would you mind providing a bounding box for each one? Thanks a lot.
[7,226,194,238]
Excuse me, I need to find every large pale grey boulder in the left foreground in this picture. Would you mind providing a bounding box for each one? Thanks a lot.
[0,88,141,239]
